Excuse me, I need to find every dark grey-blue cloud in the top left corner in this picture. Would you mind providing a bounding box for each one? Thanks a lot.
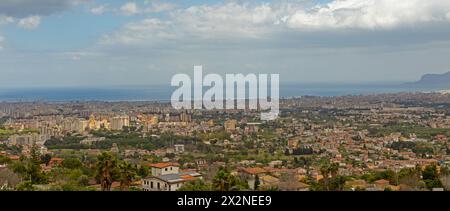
[0,0,74,18]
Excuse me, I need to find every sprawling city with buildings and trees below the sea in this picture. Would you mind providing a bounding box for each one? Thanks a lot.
[0,92,450,191]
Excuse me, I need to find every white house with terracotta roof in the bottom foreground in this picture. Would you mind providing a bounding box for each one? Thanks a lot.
[142,163,202,191]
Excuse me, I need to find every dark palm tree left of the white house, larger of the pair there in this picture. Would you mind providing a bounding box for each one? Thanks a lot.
[96,152,117,191]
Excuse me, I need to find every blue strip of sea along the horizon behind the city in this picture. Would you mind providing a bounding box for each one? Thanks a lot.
[0,83,450,102]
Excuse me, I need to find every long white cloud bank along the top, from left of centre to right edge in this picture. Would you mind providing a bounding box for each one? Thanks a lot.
[105,0,450,46]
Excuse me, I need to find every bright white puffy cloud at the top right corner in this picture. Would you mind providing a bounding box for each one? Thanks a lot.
[284,0,450,30]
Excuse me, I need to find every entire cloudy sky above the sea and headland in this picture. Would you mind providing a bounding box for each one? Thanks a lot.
[0,0,450,87]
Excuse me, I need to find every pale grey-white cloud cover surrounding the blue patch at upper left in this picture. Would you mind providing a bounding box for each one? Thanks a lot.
[0,0,450,86]
